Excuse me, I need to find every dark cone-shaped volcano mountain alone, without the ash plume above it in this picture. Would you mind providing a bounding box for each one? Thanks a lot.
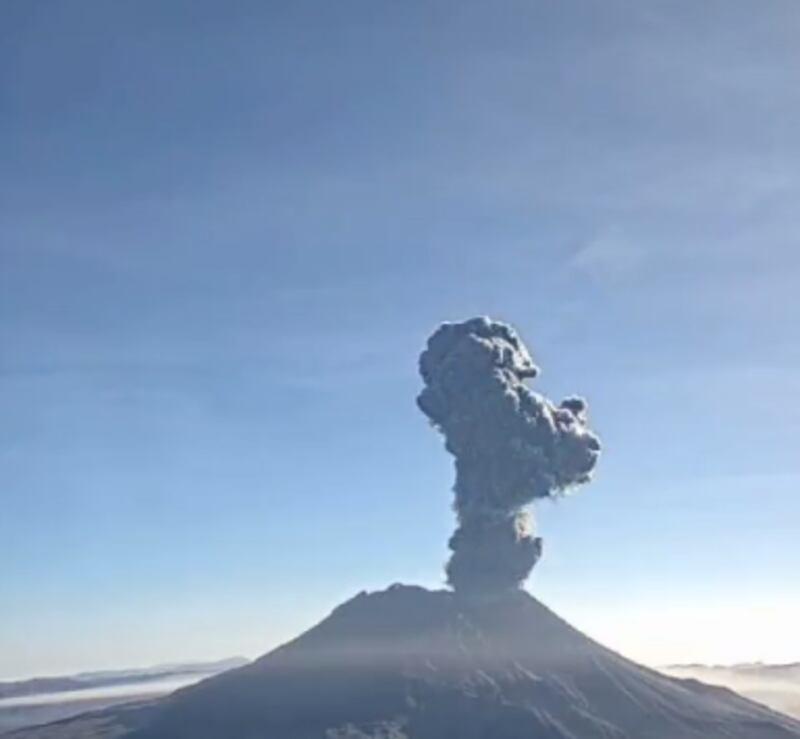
[10,585,800,739]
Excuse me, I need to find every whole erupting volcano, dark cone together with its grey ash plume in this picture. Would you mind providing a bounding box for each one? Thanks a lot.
[14,318,800,739]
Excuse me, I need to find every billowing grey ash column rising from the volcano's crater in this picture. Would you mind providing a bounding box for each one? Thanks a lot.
[417,318,600,593]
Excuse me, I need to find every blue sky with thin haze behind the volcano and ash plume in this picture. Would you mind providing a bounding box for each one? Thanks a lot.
[0,0,800,678]
